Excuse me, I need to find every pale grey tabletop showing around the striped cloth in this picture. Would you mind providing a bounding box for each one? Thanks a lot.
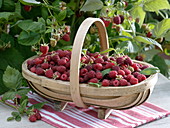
[0,74,170,128]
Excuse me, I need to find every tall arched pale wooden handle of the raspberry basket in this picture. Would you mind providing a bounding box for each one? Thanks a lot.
[70,18,109,108]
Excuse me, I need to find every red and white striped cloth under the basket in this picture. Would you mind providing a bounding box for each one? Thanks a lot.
[28,93,170,128]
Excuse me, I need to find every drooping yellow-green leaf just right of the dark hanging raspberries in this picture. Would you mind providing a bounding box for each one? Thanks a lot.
[130,5,146,26]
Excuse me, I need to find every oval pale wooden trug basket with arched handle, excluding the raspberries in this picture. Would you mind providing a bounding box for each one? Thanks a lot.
[22,18,158,118]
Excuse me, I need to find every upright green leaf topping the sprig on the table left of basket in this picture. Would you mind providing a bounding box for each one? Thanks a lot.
[3,66,23,89]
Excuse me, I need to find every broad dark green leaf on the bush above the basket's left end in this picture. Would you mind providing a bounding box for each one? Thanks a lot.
[18,31,41,46]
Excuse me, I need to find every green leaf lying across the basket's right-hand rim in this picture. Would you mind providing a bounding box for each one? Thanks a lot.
[140,67,160,75]
